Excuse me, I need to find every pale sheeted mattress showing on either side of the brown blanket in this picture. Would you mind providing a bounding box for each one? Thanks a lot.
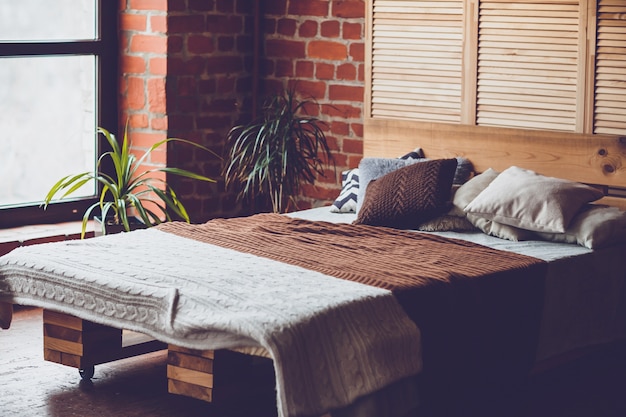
[290,207,626,362]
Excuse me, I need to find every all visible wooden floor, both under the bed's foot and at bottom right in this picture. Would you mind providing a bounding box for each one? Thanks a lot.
[0,309,626,417]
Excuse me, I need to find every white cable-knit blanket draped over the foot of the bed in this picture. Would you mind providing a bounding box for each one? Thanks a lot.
[0,229,421,417]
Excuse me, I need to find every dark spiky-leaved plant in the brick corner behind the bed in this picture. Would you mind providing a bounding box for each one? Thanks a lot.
[223,88,334,213]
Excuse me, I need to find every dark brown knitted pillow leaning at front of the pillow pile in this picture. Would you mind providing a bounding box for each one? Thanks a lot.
[354,159,457,229]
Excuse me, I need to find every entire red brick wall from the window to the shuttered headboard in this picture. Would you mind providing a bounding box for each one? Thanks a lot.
[120,0,365,221]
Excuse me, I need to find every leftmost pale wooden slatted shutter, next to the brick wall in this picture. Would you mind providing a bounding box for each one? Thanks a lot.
[370,0,463,123]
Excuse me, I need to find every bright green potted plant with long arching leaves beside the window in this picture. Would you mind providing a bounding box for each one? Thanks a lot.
[42,123,217,238]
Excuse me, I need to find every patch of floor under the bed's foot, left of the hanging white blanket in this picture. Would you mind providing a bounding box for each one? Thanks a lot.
[0,309,275,417]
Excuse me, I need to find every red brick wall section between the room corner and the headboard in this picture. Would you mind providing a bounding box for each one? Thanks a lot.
[263,0,365,208]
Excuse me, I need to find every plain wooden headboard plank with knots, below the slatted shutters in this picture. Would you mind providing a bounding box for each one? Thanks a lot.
[363,118,626,210]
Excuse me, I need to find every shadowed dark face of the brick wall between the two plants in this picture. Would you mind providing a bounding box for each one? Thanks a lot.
[166,0,254,221]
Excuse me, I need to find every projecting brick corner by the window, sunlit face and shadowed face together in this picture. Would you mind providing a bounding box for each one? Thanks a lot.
[120,0,254,221]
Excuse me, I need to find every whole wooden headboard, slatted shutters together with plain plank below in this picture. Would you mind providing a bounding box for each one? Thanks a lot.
[364,0,626,209]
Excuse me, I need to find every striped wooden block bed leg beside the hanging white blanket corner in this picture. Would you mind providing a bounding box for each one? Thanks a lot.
[167,345,215,402]
